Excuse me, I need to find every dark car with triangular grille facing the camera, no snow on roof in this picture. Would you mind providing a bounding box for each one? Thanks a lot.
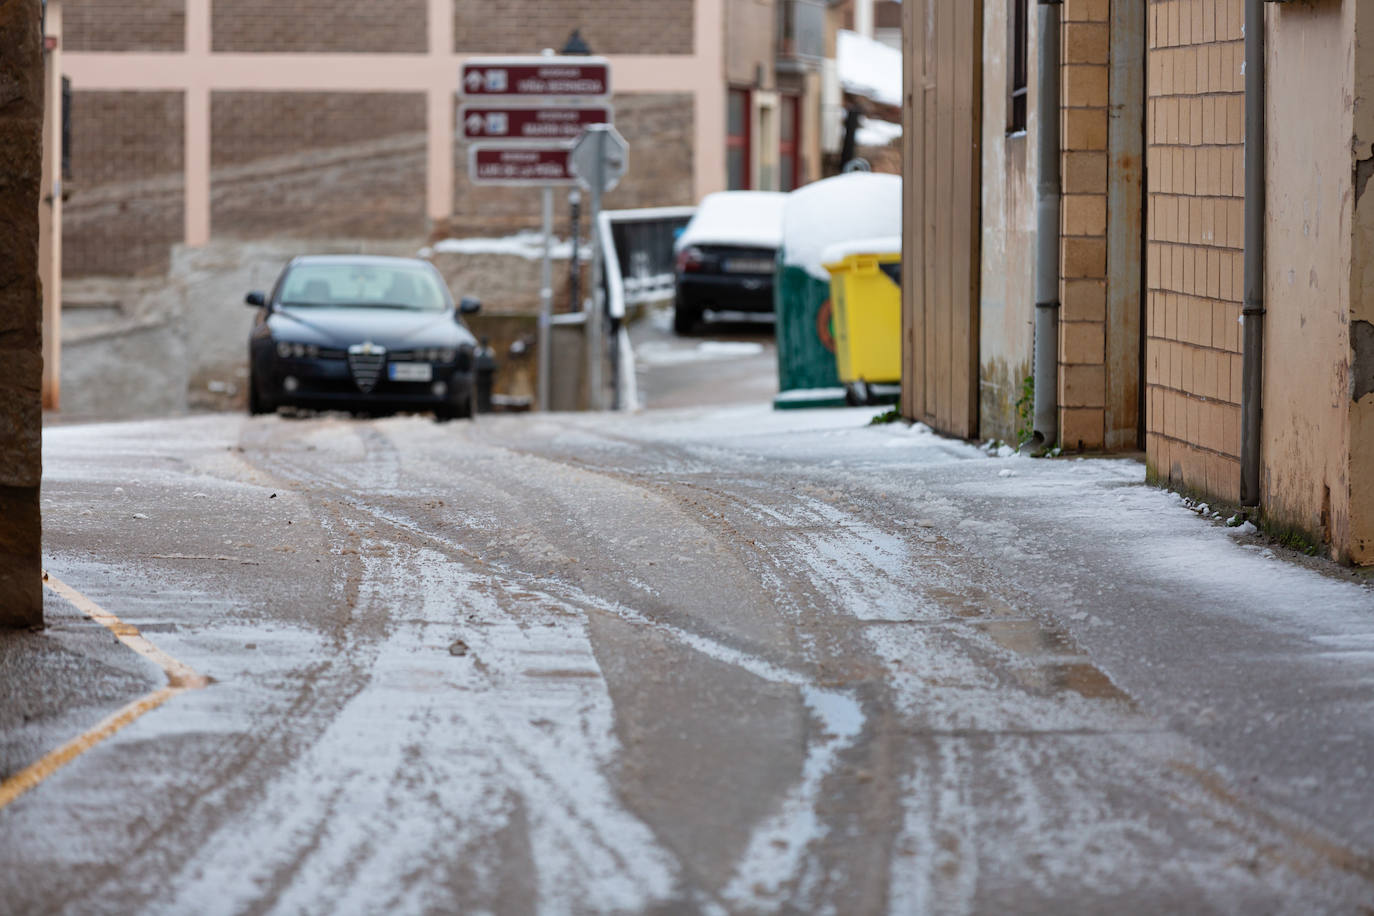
[245,255,481,419]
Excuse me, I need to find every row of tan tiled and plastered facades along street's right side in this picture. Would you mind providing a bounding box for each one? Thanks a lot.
[903,0,1374,563]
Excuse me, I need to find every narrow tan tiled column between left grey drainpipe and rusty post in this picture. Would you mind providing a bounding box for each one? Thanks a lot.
[1059,0,1112,449]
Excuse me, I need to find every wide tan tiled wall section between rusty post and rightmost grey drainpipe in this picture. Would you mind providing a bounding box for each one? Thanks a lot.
[1146,0,1245,501]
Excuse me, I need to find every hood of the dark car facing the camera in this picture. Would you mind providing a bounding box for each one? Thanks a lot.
[268,306,477,350]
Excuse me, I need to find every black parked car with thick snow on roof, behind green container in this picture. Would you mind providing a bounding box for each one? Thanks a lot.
[673,191,787,334]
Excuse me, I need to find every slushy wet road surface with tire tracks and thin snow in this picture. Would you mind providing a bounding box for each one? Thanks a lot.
[0,311,1374,913]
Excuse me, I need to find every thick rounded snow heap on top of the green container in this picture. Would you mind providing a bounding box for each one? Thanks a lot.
[782,172,901,283]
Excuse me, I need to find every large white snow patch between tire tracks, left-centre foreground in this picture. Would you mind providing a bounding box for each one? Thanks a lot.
[155,551,677,913]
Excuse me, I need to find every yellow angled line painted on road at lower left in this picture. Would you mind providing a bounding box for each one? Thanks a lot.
[0,573,210,809]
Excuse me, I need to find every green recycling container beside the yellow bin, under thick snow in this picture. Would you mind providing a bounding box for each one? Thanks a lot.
[774,262,845,409]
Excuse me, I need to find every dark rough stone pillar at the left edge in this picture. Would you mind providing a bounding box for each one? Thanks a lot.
[0,0,43,626]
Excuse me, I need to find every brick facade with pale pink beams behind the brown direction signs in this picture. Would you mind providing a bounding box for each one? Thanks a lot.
[63,0,725,276]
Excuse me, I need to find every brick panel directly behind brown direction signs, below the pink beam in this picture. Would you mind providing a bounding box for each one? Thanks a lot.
[444,93,695,238]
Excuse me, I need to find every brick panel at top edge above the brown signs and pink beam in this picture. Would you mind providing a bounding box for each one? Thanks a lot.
[453,0,695,54]
